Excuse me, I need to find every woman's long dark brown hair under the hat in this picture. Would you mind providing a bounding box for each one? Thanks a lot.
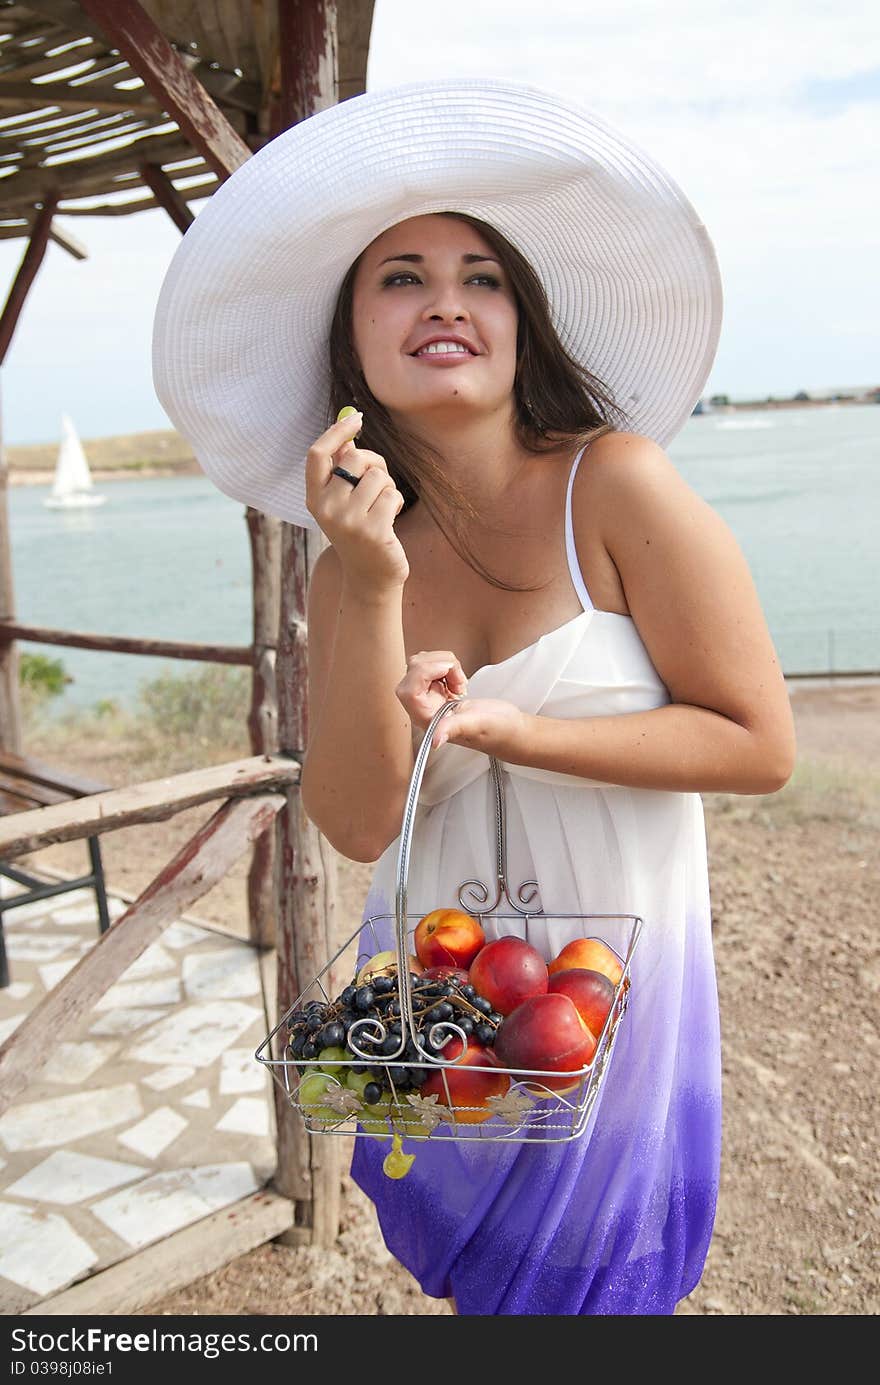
[327,212,622,591]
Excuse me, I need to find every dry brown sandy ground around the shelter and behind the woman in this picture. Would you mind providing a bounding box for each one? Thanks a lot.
[15,684,880,1316]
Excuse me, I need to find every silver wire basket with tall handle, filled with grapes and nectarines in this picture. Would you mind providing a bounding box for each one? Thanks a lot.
[255,698,643,1177]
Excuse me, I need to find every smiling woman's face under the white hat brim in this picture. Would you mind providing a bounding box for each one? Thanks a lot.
[352,215,517,417]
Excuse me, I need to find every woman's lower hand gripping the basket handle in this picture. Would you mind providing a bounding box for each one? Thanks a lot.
[395,650,525,759]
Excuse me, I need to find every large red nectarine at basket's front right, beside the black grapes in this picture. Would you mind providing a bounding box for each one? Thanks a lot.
[495,992,596,1091]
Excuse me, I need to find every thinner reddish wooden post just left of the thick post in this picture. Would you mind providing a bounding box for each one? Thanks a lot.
[245,507,281,947]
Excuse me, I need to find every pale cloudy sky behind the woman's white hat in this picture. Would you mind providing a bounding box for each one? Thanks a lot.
[0,0,880,445]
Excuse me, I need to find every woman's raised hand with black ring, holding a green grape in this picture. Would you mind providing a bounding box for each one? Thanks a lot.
[305,413,409,590]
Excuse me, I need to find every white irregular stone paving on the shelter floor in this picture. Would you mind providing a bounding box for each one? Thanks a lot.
[0,878,276,1314]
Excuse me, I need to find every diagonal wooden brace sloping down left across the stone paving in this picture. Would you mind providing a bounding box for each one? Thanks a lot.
[0,794,284,1114]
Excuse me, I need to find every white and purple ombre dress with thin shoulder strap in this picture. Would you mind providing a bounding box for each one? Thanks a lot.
[352,454,721,1316]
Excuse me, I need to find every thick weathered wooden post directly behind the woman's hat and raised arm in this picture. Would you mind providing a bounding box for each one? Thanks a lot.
[273,0,341,1247]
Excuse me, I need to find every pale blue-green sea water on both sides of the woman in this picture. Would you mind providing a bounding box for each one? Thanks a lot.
[10,404,880,711]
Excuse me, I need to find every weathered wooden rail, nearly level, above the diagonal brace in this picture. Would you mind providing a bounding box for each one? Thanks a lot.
[0,753,299,860]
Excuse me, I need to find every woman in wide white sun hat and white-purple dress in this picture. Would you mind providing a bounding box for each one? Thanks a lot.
[157,82,794,1314]
